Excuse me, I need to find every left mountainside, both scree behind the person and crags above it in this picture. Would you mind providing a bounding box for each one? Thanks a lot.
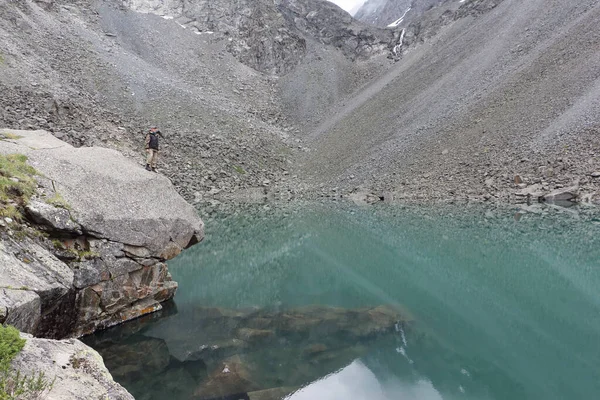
[0,0,400,201]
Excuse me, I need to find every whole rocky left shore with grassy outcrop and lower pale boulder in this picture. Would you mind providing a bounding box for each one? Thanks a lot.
[0,130,204,400]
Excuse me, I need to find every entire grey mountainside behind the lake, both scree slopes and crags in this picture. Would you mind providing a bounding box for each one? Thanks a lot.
[0,0,600,203]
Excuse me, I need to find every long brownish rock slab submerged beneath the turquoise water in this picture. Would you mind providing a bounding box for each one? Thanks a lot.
[151,305,412,363]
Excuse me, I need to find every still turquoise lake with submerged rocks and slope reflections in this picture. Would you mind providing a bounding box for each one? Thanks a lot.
[85,206,600,400]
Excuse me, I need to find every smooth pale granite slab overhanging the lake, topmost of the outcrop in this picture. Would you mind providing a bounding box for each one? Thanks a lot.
[0,130,204,257]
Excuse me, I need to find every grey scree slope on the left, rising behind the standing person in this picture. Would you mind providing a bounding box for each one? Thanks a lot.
[0,0,290,199]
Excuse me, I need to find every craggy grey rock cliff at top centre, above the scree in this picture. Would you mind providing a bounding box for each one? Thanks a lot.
[124,0,400,75]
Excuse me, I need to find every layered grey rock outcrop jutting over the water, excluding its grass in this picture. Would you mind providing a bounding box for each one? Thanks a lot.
[0,131,203,338]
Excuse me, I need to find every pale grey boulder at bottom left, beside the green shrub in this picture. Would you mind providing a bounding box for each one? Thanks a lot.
[12,334,133,400]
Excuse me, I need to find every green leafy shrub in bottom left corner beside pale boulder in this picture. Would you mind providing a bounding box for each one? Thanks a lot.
[0,325,54,400]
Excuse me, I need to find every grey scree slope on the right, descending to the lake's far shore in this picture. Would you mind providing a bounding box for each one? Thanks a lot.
[301,0,600,200]
